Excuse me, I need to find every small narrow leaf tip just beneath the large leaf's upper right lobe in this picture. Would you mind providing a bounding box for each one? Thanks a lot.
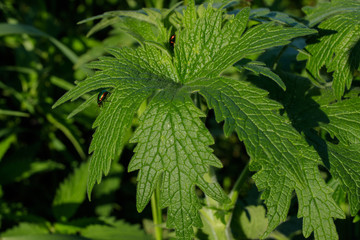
[234,61,286,91]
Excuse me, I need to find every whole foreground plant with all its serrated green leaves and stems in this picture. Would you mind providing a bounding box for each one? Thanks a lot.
[48,1,360,239]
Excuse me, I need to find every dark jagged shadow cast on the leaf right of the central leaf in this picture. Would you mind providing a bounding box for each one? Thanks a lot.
[248,71,330,169]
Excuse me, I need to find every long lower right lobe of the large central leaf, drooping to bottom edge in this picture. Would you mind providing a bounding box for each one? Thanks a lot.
[187,78,345,239]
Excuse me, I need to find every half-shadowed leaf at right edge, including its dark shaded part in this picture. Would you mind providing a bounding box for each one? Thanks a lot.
[250,74,360,221]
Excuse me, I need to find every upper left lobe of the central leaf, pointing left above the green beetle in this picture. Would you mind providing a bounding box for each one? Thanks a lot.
[53,46,177,108]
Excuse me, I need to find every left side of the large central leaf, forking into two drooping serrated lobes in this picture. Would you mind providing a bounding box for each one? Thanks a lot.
[64,46,176,196]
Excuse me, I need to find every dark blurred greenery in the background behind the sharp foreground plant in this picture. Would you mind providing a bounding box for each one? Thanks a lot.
[0,0,359,239]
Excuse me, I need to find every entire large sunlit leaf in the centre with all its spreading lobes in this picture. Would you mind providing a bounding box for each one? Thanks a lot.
[50,0,344,239]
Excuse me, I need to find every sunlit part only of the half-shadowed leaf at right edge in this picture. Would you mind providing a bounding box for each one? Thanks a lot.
[321,97,360,216]
